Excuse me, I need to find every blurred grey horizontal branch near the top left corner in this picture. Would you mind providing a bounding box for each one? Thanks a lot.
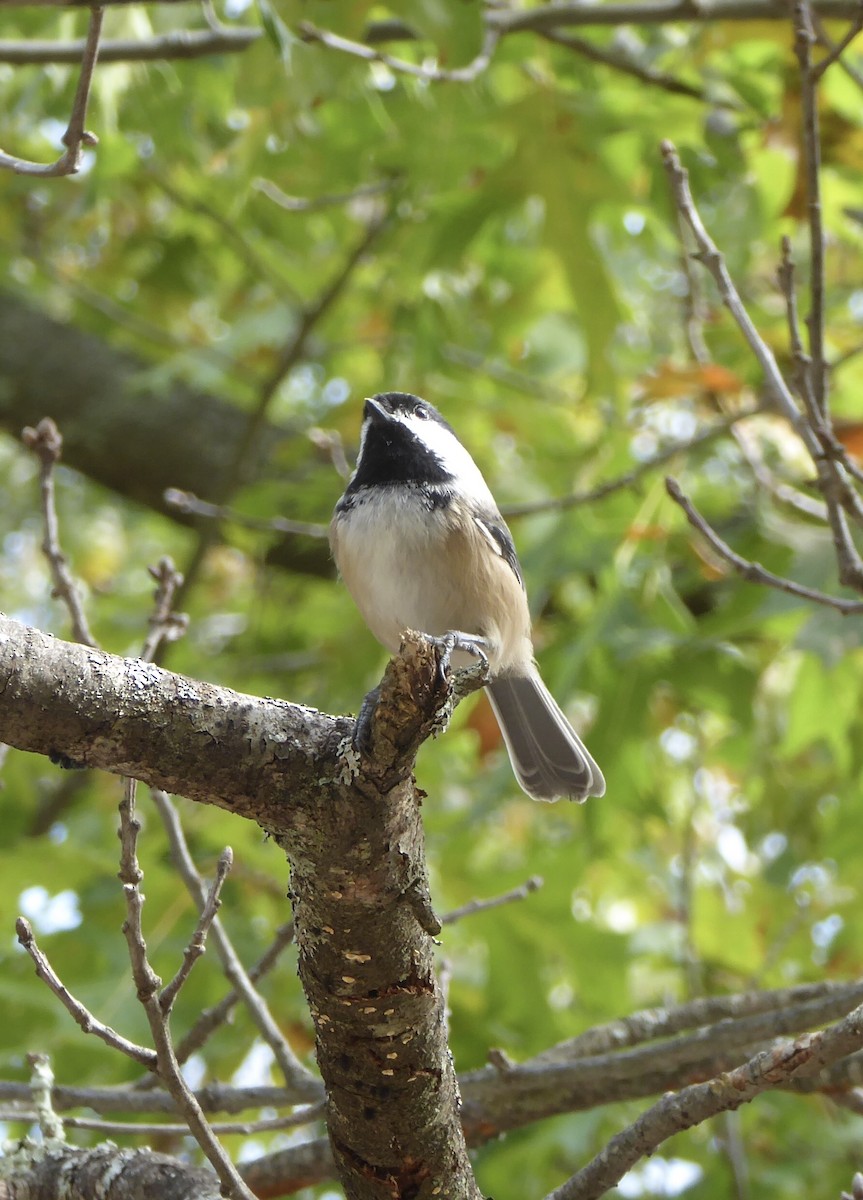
[0,26,263,66]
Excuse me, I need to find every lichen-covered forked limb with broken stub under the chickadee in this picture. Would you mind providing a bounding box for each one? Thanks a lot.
[0,617,480,1200]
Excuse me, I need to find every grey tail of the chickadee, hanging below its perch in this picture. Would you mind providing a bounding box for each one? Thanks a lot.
[487,671,605,802]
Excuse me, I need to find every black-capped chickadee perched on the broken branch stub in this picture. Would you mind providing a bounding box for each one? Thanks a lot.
[330,391,605,800]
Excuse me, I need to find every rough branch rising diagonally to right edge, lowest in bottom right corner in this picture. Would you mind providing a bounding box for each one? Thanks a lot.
[546,1006,863,1200]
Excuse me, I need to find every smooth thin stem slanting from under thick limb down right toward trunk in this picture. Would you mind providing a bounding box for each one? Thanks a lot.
[151,787,322,1100]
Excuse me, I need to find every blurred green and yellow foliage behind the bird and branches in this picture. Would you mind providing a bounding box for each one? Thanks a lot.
[0,0,863,1200]
